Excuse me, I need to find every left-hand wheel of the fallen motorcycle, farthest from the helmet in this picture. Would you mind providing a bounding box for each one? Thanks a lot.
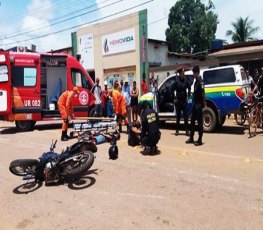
[9,159,41,176]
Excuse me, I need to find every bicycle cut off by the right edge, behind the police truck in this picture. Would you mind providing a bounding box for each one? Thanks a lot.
[248,95,263,137]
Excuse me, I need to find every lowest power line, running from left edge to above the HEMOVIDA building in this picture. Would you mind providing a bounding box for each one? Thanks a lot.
[2,0,154,46]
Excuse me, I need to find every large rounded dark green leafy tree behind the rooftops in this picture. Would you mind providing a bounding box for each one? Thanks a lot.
[165,0,218,53]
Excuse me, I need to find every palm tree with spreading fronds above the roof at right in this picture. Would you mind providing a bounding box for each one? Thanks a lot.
[226,16,260,42]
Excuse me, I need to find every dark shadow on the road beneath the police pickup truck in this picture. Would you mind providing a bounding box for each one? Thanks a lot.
[160,123,248,135]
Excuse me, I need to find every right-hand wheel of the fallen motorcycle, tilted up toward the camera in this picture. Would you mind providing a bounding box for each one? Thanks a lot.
[65,151,94,178]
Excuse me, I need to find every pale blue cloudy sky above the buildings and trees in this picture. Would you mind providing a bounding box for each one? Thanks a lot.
[0,0,263,51]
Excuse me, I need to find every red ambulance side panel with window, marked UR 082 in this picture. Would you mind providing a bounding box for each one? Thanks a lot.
[11,54,41,120]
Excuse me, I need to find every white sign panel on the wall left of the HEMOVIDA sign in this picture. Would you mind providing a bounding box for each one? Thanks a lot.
[78,33,94,69]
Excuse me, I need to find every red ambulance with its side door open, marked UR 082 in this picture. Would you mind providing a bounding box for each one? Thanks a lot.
[0,51,98,131]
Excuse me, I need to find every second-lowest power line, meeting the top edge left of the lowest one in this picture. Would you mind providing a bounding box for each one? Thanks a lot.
[0,0,123,41]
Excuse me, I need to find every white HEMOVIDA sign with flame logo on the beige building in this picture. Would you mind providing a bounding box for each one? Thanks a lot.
[102,29,135,55]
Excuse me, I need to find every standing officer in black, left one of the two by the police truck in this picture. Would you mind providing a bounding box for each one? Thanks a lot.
[172,68,191,136]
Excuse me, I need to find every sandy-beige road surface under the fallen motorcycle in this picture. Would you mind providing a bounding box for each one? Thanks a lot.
[0,119,263,230]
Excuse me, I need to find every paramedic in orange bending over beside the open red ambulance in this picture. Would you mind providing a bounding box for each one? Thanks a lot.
[58,86,79,141]
